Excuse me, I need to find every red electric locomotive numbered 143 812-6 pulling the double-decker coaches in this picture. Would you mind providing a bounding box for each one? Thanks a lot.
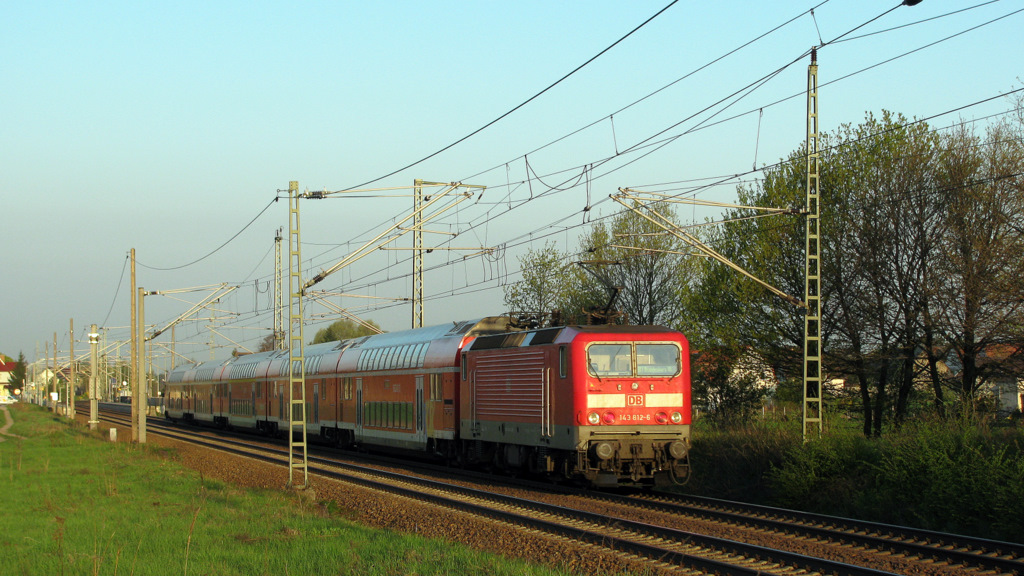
[459,326,690,486]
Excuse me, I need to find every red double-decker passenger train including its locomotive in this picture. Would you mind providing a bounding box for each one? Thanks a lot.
[165,317,691,487]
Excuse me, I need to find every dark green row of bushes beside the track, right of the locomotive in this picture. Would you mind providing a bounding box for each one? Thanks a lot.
[680,417,1024,542]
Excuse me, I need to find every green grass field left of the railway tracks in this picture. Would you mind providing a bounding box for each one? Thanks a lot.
[0,405,610,576]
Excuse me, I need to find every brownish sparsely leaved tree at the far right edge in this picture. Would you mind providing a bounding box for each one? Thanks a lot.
[931,123,1024,406]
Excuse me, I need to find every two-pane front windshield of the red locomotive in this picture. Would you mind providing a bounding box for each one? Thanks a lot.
[587,342,681,377]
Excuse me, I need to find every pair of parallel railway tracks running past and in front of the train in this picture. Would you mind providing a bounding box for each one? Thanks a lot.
[92,403,1024,576]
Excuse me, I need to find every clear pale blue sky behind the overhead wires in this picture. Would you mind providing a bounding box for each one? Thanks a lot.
[0,0,1024,360]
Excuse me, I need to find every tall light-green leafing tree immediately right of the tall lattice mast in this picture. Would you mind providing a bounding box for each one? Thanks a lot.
[821,112,943,436]
